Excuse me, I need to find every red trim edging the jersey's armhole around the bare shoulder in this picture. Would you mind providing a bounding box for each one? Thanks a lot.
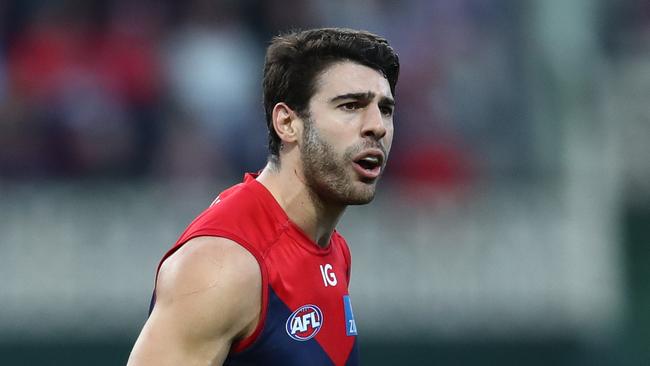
[150,230,269,353]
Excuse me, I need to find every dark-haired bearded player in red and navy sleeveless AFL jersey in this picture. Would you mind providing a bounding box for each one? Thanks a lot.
[129,29,399,366]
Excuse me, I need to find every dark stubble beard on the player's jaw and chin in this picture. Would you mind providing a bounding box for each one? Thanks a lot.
[300,117,375,206]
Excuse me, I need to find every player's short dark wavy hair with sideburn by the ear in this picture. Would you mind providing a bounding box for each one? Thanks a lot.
[263,28,399,161]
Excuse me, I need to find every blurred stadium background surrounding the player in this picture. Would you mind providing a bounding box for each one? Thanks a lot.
[0,0,650,365]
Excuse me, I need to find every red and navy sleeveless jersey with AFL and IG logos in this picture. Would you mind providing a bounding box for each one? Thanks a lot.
[152,174,358,366]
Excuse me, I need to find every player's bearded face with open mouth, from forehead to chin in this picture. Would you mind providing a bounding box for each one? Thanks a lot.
[300,61,394,205]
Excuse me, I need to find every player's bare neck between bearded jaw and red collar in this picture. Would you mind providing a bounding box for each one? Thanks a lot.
[257,160,346,248]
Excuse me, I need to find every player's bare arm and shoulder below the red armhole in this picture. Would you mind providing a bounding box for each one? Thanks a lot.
[128,237,262,366]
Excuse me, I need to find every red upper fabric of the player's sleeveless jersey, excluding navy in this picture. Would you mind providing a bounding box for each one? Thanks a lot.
[153,174,356,365]
